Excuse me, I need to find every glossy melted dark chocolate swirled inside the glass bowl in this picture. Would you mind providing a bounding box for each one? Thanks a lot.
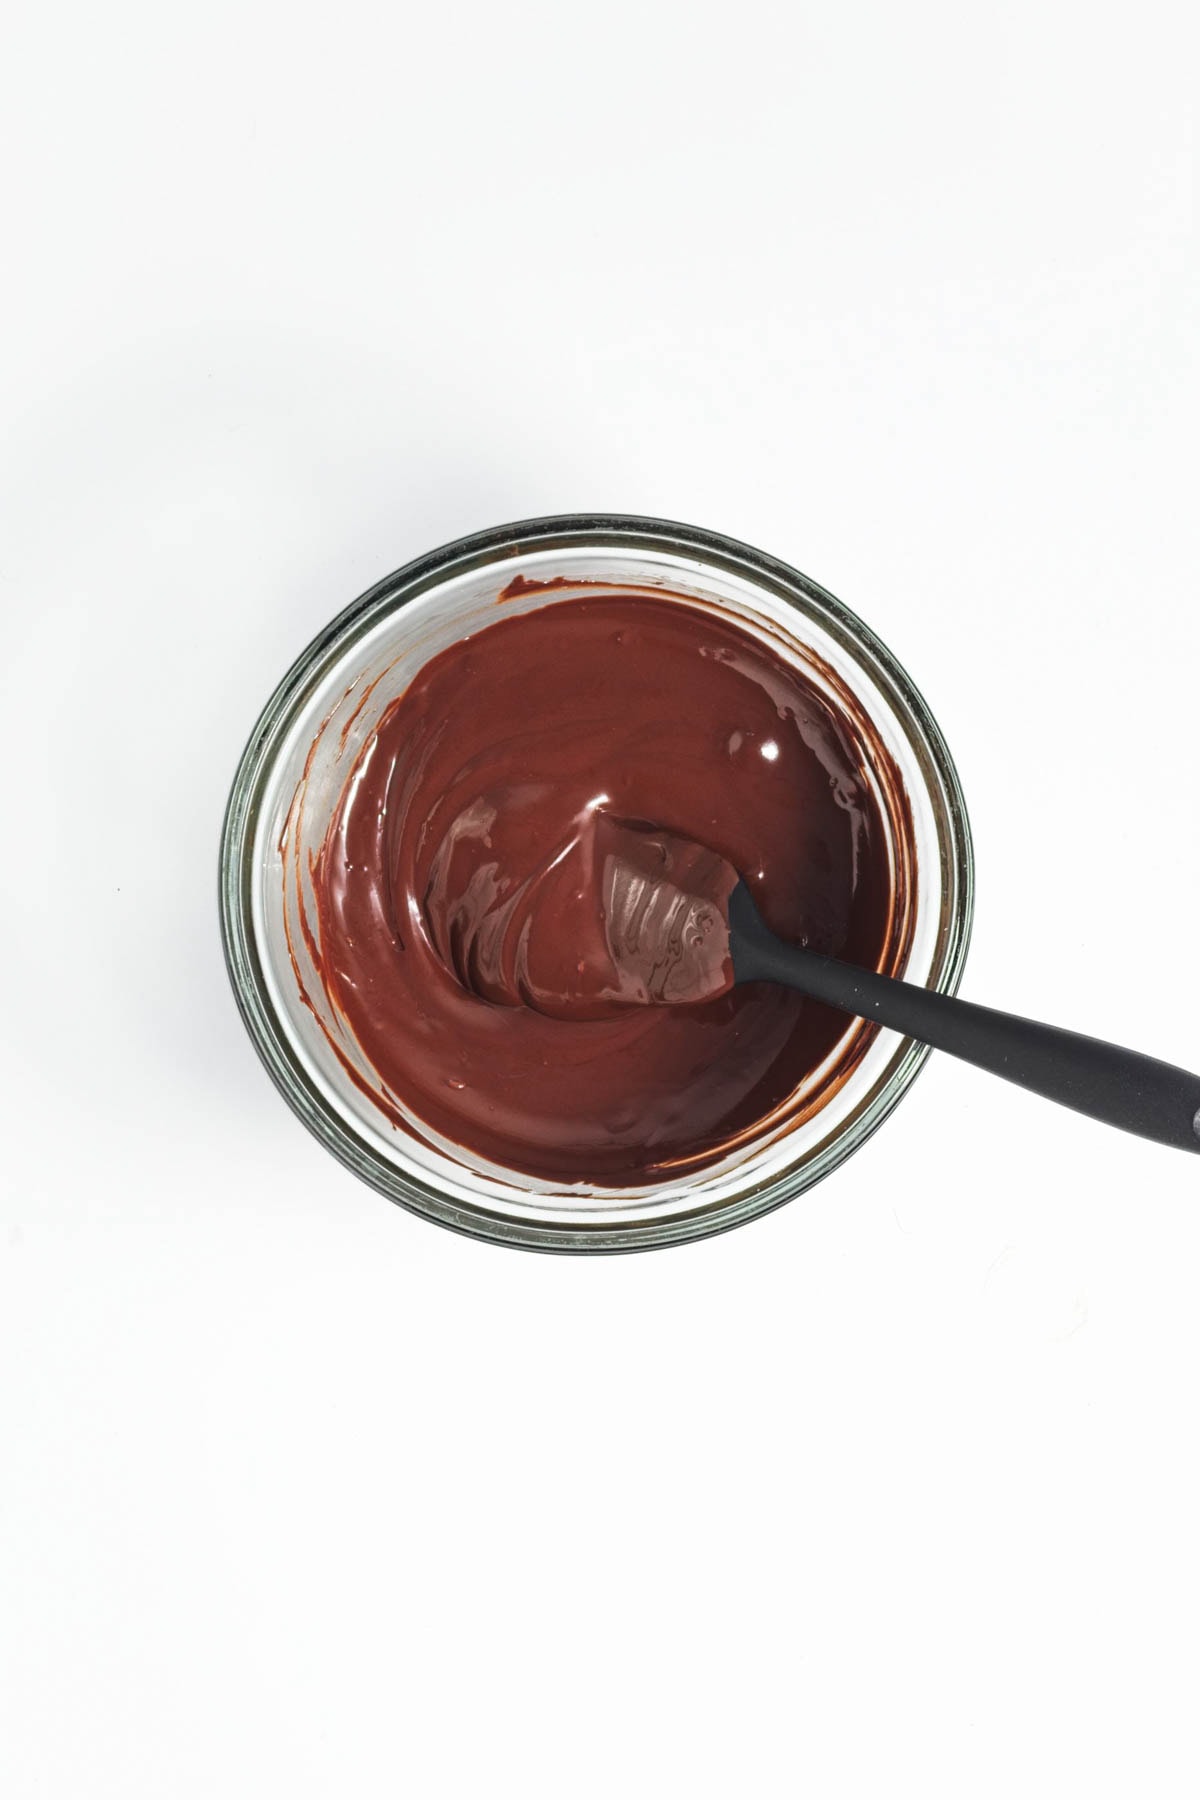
[313,592,912,1186]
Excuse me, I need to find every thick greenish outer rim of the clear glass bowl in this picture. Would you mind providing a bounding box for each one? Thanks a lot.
[219,513,975,1255]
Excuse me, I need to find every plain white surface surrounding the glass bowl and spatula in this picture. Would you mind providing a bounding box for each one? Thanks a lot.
[0,0,1200,1800]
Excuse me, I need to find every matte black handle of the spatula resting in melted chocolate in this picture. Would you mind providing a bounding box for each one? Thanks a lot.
[729,882,1200,1152]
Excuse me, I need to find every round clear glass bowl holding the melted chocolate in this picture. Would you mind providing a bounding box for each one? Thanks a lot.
[221,515,973,1251]
